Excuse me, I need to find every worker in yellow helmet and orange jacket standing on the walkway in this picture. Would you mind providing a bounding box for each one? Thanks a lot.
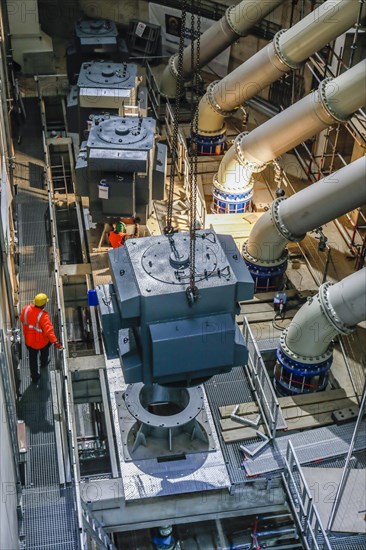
[20,293,62,383]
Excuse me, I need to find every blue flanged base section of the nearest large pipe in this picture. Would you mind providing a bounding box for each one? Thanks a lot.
[275,348,333,395]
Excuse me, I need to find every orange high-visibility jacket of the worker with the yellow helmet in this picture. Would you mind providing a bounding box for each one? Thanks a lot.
[20,304,57,349]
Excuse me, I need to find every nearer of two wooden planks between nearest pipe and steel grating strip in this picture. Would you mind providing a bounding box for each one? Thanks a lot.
[220,397,357,431]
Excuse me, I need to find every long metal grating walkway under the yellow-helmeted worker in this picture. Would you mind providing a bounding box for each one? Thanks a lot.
[17,190,80,550]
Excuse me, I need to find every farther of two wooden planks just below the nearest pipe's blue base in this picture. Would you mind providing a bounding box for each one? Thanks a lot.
[219,388,355,418]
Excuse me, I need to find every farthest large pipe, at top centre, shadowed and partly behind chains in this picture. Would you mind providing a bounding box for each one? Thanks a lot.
[160,0,284,98]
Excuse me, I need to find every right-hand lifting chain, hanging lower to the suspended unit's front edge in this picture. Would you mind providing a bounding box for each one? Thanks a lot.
[187,0,201,304]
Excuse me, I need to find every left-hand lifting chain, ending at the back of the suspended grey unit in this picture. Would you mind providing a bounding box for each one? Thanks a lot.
[164,0,188,235]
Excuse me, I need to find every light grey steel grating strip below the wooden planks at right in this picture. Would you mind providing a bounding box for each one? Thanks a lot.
[243,421,366,476]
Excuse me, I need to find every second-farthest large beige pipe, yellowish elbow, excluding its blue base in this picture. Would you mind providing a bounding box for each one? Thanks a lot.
[198,0,366,137]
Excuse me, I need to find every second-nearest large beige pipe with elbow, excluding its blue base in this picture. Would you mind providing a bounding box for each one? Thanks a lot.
[244,156,366,265]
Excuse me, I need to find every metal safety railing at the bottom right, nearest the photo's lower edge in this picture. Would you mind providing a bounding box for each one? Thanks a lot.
[282,441,332,550]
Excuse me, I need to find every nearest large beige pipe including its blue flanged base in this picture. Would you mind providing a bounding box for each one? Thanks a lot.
[275,268,366,395]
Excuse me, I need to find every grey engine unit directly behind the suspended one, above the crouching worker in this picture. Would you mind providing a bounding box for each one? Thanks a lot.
[75,116,167,224]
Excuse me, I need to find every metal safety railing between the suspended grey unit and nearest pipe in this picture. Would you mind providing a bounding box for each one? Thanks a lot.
[243,317,286,439]
